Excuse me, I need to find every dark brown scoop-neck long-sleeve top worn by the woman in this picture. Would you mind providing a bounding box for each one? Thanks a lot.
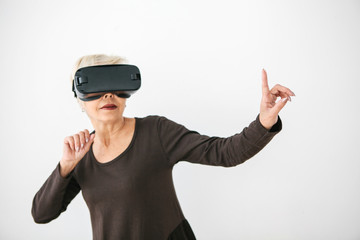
[32,116,282,240]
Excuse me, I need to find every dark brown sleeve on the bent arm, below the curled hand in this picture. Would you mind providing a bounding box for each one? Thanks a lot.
[31,164,80,223]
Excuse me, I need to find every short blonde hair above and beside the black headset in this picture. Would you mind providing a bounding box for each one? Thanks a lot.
[70,54,128,84]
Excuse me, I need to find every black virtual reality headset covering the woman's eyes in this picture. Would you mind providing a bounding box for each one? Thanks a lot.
[72,64,141,101]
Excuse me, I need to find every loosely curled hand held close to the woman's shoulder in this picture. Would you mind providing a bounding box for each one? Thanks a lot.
[60,129,95,177]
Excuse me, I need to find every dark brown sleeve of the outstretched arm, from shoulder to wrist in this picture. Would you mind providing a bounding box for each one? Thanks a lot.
[158,115,282,167]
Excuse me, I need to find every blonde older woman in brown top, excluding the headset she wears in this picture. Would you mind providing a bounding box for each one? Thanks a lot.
[32,55,295,240]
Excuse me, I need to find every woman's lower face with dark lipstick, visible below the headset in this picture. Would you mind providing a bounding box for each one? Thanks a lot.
[79,92,126,122]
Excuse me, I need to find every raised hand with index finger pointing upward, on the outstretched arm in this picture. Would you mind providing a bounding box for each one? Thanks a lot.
[260,69,295,130]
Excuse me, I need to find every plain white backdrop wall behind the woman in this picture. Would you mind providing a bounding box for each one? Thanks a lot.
[0,0,360,240]
